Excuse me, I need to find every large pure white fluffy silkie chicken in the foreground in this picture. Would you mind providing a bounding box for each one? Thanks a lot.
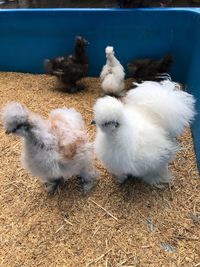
[94,80,195,187]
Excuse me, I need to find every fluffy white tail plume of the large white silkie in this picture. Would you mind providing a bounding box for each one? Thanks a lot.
[124,80,195,137]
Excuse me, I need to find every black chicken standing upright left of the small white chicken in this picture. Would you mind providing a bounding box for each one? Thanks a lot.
[44,36,89,93]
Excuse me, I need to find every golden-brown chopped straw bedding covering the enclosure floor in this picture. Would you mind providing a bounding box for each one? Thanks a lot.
[0,73,200,267]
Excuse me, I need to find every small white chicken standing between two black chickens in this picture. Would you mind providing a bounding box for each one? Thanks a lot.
[100,46,125,96]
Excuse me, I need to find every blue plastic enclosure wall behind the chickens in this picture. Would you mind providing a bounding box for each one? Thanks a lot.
[0,8,200,172]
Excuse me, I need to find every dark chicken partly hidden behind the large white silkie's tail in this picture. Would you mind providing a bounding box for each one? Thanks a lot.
[128,54,173,82]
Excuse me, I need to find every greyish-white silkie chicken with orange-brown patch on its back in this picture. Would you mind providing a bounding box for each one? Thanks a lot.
[2,102,97,194]
